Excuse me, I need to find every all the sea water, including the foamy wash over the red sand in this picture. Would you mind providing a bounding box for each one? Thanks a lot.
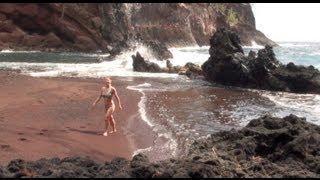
[0,42,320,160]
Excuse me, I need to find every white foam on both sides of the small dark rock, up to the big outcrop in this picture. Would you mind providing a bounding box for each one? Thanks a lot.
[0,44,209,78]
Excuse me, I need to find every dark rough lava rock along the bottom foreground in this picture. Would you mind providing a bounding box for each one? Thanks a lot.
[0,115,320,178]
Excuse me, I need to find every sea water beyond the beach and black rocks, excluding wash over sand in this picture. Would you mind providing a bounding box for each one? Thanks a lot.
[0,42,320,77]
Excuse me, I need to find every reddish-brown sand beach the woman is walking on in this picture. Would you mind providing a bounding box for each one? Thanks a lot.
[0,71,155,164]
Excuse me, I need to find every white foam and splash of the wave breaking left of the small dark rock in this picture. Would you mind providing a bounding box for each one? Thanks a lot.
[0,45,178,78]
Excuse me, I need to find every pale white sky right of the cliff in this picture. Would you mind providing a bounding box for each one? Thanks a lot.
[251,3,320,42]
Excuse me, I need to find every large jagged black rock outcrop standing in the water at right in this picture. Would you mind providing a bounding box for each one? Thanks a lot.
[202,28,320,93]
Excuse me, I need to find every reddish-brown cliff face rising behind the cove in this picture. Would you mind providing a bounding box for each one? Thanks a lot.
[0,3,274,51]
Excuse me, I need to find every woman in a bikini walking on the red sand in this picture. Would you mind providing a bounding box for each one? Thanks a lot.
[92,78,122,136]
